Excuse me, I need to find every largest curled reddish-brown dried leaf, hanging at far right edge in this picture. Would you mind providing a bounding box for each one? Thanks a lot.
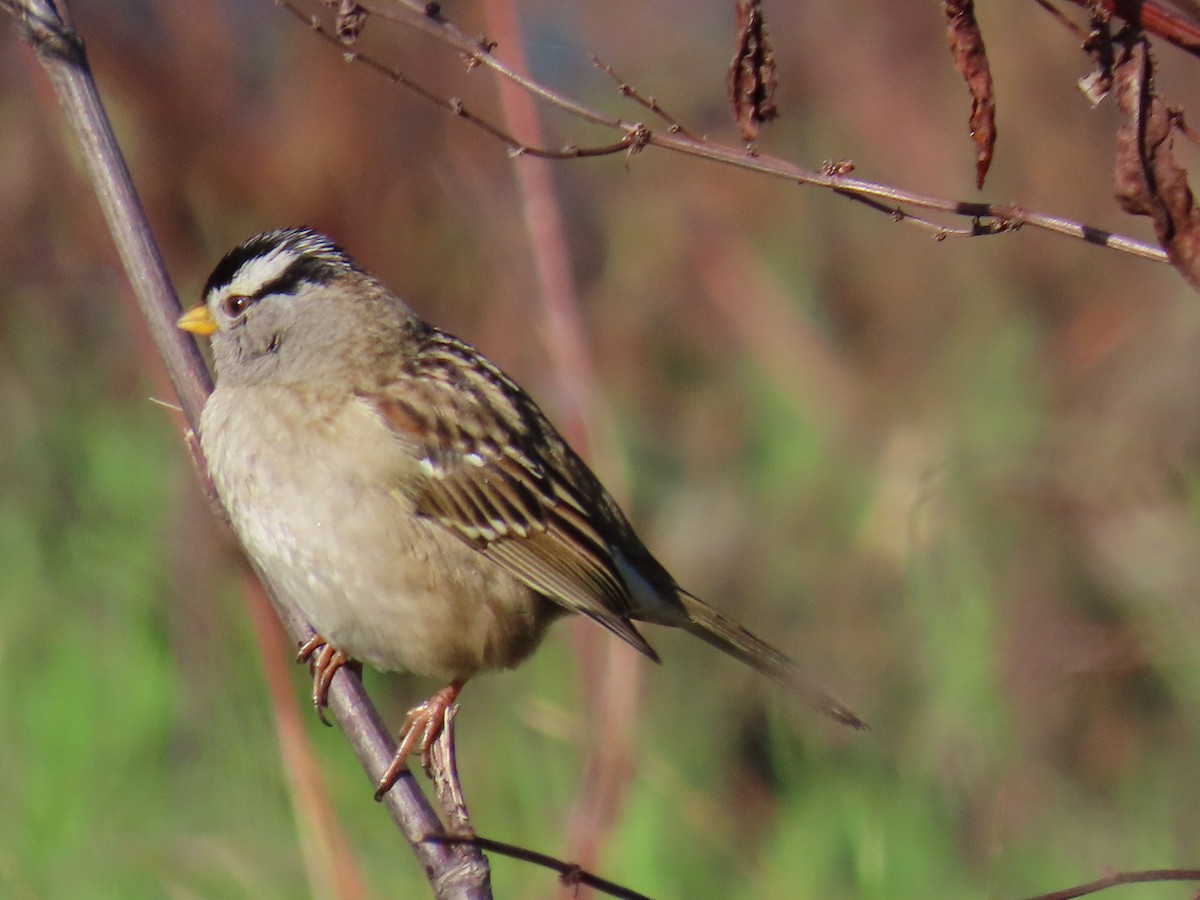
[1114,32,1200,289]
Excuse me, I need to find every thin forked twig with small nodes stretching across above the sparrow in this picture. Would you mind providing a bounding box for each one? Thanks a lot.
[275,0,1168,263]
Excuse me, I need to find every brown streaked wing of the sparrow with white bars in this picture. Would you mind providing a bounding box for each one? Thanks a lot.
[361,332,659,661]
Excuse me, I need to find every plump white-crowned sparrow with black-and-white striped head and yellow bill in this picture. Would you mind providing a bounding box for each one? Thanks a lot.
[179,228,863,791]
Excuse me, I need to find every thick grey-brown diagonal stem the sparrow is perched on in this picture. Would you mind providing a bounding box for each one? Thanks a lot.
[0,0,491,900]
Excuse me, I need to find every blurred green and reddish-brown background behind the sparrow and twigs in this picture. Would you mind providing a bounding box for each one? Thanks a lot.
[0,0,1200,899]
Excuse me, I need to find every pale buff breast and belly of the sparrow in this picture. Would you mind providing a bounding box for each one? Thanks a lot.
[200,388,560,679]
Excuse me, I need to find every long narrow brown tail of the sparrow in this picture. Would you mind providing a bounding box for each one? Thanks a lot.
[679,589,868,728]
